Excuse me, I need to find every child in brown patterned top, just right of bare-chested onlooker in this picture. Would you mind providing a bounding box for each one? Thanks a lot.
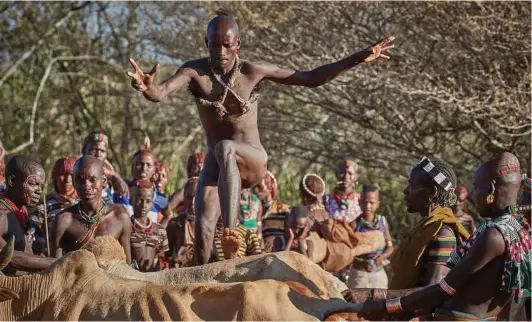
[131,179,169,272]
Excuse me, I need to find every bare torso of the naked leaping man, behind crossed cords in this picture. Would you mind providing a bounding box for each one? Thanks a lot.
[185,58,262,150]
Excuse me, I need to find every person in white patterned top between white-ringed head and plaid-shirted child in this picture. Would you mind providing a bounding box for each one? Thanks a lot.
[325,160,362,225]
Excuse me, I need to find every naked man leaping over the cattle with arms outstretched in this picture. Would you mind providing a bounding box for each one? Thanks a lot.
[128,12,393,264]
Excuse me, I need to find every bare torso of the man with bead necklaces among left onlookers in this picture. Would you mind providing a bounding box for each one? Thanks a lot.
[56,205,127,254]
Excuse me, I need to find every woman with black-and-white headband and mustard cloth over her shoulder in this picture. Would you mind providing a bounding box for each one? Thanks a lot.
[390,157,469,289]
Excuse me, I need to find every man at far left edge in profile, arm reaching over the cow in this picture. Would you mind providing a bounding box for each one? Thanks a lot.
[0,155,55,275]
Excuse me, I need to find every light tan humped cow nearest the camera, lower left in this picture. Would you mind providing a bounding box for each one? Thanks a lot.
[0,235,361,321]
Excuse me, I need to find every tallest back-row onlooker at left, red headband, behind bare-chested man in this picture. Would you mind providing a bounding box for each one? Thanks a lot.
[81,131,129,203]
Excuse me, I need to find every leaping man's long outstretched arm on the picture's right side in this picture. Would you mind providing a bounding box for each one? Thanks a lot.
[255,37,394,87]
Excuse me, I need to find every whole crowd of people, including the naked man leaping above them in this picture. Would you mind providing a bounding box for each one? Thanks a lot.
[0,8,531,320]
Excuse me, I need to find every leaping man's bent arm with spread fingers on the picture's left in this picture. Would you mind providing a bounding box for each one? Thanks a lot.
[127,58,193,102]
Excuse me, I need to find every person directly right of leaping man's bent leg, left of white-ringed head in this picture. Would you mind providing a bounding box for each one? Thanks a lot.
[252,171,291,253]
